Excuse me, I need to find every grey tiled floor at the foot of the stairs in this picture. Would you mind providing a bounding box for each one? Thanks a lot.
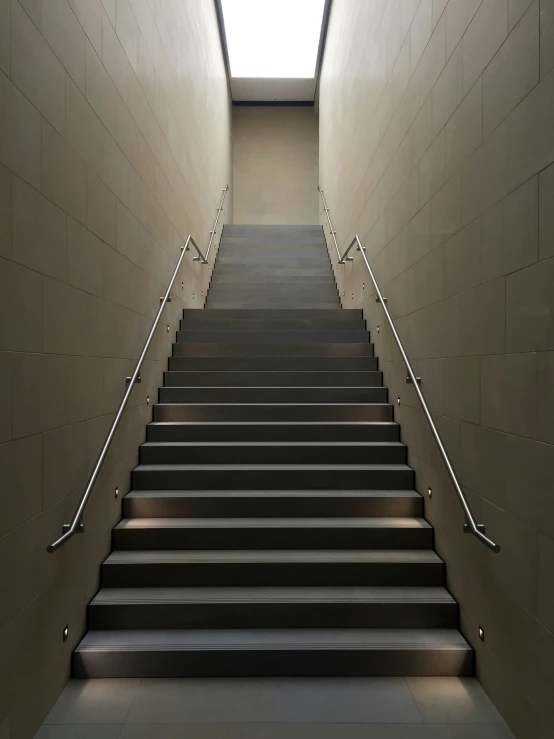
[35,678,513,739]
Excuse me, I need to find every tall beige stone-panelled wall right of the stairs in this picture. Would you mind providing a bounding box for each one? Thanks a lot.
[320,0,554,739]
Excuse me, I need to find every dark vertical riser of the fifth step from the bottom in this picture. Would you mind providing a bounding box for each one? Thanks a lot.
[123,491,423,518]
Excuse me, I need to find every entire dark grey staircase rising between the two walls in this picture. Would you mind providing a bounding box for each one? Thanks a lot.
[74,226,473,677]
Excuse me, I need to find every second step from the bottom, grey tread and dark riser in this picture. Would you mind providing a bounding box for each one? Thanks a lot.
[88,586,458,630]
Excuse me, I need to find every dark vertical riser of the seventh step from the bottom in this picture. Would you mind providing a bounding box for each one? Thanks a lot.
[140,443,407,464]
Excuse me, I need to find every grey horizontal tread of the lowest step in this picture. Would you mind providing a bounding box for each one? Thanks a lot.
[77,629,471,652]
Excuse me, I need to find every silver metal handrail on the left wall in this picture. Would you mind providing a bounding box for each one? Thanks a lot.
[47,185,229,553]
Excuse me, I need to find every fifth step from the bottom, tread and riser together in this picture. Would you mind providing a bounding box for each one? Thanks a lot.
[123,490,423,518]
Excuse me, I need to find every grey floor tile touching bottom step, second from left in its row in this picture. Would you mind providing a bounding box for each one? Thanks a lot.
[127,679,271,724]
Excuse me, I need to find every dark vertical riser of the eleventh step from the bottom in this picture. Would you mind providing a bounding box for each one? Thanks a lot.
[164,372,383,388]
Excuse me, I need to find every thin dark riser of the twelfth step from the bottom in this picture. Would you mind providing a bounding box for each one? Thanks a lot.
[169,356,378,372]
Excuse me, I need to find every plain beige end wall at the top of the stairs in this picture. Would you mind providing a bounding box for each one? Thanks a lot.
[233,105,318,225]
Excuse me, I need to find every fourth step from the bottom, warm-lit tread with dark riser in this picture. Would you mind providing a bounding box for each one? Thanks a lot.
[113,517,433,550]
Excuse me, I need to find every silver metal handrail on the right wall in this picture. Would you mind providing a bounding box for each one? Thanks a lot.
[318,187,500,552]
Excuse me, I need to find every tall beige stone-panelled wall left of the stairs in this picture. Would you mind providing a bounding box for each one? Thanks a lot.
[0,0,230,739]
